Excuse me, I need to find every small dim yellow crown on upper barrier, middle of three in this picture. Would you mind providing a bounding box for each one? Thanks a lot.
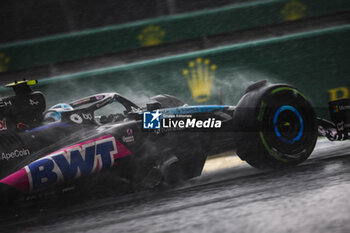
[137,25,165,46]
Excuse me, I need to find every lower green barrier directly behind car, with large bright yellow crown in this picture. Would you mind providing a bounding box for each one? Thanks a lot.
[1,25,350,116]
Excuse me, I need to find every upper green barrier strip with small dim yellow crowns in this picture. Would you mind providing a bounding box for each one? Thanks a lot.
[0,0,350,72]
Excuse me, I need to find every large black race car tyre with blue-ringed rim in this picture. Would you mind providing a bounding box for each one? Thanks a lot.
[234,81,317,169]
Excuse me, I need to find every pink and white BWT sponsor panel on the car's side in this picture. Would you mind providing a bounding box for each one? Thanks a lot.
[0,135,130,192]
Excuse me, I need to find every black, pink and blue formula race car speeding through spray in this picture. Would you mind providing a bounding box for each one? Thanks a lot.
[0,81,350,202]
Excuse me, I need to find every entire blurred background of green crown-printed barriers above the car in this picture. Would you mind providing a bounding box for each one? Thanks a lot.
[0,0,350,114]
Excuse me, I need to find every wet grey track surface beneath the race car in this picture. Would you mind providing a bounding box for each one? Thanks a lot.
[0,140,350,232]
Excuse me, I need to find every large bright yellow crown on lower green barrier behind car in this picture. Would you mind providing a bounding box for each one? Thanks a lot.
[182,57,217,103]
